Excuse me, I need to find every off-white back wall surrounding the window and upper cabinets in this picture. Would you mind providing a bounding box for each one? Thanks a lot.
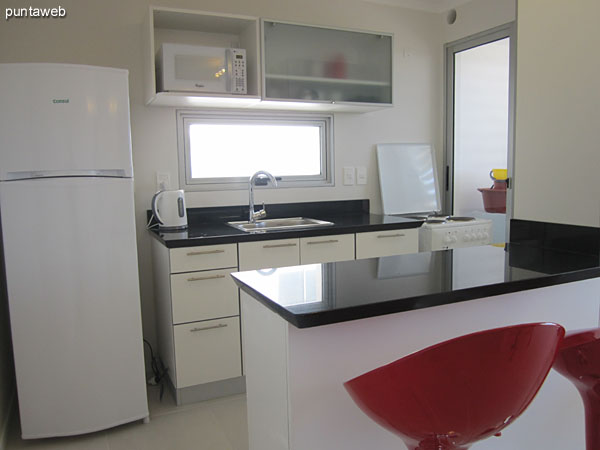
[0,0,443,376]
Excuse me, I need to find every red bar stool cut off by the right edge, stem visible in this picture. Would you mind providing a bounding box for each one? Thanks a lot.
[554,328,600,450]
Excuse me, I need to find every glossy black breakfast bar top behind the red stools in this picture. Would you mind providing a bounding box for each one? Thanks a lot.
[232,244,600,328]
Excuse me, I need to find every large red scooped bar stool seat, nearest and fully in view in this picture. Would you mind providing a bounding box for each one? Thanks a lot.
[344,323,565,450]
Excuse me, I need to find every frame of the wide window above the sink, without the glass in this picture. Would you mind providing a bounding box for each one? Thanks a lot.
[176,110,335,191]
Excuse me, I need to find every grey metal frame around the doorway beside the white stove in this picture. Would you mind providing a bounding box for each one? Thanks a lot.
[442,21,517,242]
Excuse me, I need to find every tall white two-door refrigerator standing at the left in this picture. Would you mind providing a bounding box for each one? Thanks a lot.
[0,63,148,439]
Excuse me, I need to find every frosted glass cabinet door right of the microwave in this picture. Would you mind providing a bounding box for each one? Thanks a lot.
[263,21,392,104]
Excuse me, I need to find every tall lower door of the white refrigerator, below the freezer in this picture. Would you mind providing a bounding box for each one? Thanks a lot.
[0,178,148,438]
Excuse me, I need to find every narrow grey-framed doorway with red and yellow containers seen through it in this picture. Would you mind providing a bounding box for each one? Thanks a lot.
[444,23,516,243]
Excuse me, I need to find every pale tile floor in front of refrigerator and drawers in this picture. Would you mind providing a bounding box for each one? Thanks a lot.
[7,387,248,450]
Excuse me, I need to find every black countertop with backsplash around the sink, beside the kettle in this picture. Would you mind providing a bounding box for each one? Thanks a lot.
[150,200,422,248]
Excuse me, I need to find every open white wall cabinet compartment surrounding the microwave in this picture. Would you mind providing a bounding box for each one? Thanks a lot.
[143,6,261,107]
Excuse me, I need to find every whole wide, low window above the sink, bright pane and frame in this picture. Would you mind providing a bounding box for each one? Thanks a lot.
[177,110,333,190]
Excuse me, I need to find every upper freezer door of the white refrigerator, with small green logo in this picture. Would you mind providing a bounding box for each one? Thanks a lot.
[0,63,132,180]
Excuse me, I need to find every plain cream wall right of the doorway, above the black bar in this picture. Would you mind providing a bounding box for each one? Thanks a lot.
[514,0,600,227]
